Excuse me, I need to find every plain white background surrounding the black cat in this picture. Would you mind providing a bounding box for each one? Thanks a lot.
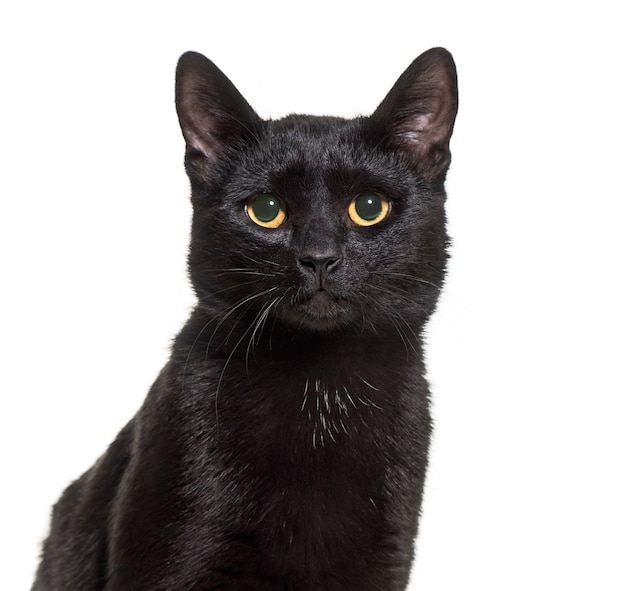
[0,0,626,591]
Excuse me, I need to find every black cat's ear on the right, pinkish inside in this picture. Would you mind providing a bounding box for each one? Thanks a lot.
[372,47,458,180]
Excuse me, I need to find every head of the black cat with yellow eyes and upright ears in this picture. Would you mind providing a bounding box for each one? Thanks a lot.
[176,49,457,332]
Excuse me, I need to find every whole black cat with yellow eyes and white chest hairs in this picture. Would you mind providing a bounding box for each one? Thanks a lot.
[33,49,457,591]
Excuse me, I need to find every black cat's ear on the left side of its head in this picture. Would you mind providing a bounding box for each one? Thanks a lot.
[176,51,260,180]
